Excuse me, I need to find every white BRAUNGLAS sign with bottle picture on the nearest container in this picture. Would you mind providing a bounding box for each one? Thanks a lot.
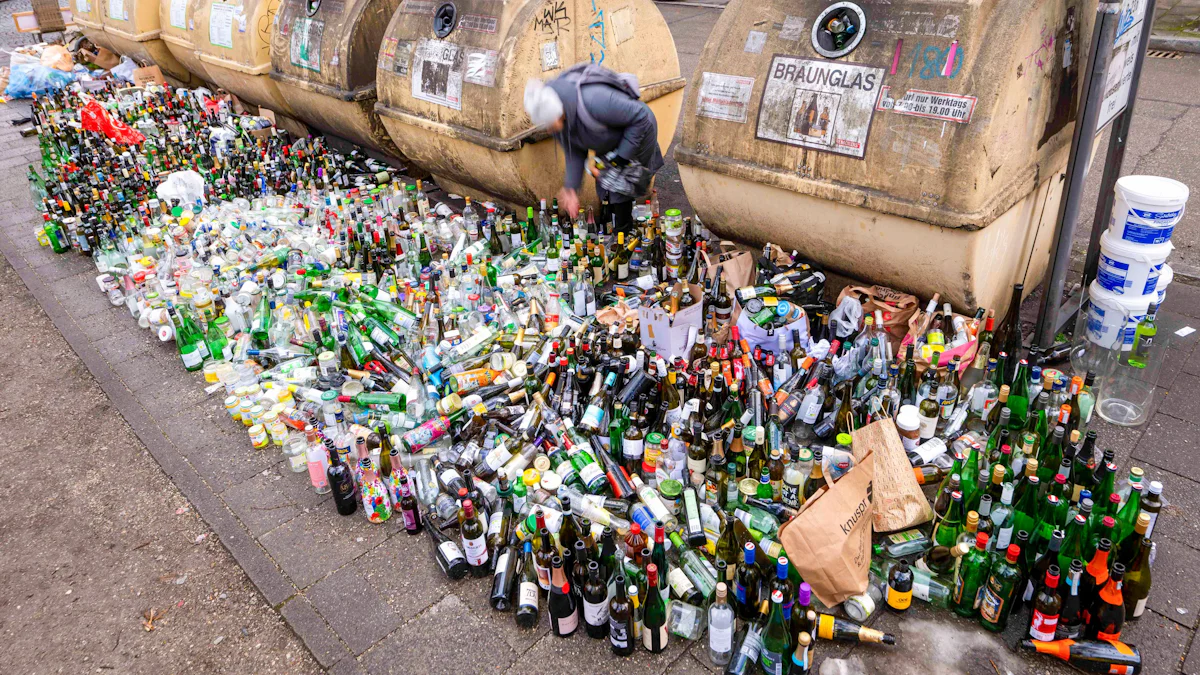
[756,55,883,157]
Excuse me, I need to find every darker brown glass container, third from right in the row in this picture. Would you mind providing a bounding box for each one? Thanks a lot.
[271,0,400,155]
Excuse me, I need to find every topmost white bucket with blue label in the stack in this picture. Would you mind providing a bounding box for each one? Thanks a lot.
[1109,175,1188,244]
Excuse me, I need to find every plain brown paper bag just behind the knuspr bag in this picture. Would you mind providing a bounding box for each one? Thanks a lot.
[851,418,934,532]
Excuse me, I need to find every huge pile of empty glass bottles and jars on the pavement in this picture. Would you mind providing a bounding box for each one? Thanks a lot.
[30,79,1162,674]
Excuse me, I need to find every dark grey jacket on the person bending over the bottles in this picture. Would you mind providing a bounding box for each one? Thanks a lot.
[546,67,662,198]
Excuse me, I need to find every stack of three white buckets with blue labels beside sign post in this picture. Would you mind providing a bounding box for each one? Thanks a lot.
[1087,175,1188,351]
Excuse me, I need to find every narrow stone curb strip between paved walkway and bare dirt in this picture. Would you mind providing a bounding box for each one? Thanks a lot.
[0,224,354,669]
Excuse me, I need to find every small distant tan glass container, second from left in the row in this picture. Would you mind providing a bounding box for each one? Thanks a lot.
[94,0,198,84]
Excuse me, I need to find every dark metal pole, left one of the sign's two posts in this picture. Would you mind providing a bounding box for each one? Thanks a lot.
[1033,1,1121,347]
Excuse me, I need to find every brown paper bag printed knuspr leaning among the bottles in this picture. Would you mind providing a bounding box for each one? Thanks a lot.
[779,454,875,607]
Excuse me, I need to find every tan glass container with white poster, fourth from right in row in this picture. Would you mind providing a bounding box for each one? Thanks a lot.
[188,0,293,115]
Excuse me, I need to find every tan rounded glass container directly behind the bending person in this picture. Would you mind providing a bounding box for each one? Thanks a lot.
[377,0,684,207]
